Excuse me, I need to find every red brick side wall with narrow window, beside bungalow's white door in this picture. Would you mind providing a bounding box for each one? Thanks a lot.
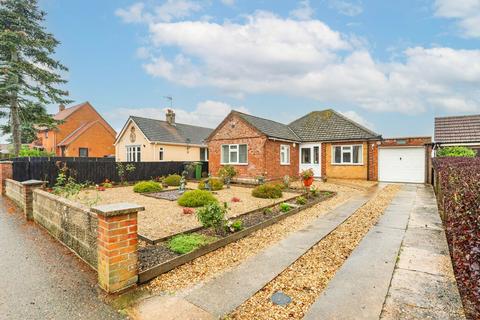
[265,140,299,179]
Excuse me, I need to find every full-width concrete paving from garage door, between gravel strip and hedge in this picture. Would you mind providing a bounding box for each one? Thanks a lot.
[304,185,462,320]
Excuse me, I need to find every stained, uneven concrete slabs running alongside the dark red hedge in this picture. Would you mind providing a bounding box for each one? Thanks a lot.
[380,186,465,320]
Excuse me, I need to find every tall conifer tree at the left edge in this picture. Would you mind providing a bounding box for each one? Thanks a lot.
[0,0,70,155]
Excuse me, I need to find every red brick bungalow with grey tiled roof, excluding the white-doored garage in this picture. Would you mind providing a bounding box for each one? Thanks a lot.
[207,109,382,182]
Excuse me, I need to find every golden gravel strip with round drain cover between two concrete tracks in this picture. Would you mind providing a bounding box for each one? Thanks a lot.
[229,185,401,319]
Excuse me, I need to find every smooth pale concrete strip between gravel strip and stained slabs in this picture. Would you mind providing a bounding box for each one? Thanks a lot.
[304,186,416,320]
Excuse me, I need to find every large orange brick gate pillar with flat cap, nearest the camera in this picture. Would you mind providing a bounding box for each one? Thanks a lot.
[91,203,145,293]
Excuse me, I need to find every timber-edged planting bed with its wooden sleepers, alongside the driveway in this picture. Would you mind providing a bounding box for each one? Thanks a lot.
[139,192,334,283]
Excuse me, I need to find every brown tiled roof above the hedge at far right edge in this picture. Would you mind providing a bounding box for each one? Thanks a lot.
[434,115,480,143]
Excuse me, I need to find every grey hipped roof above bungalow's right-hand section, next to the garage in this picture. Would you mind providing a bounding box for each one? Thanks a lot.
[289,109,381,142]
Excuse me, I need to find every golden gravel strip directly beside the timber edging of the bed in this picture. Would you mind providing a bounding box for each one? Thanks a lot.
[148,182,374,293]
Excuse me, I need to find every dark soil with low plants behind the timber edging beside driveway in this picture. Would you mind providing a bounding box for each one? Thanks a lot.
[139,192,335,272]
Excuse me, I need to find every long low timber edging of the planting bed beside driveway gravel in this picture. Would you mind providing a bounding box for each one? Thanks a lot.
[138,191,337,284]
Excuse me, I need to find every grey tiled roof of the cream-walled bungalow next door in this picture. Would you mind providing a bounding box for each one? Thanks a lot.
[130,116,213,145]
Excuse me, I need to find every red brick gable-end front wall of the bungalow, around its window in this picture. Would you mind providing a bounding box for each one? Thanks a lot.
[208,115,267,178]
